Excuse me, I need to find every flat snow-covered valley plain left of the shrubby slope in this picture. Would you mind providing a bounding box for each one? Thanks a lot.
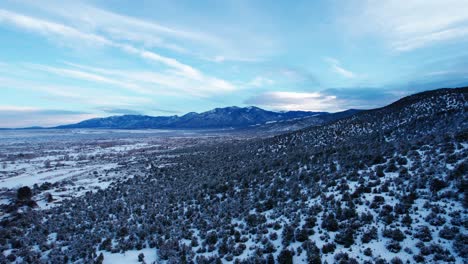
[0,129,239,208]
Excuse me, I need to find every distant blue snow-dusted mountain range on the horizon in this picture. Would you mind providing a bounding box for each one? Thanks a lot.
[55,106,357,129]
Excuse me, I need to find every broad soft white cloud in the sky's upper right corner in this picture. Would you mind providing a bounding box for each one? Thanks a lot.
[347,0,468,52]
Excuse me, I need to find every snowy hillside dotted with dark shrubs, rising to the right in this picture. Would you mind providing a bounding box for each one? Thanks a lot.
[0,88,468,263]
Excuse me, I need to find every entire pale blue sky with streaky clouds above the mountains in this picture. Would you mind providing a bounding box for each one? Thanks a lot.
[0,0,468,127]
